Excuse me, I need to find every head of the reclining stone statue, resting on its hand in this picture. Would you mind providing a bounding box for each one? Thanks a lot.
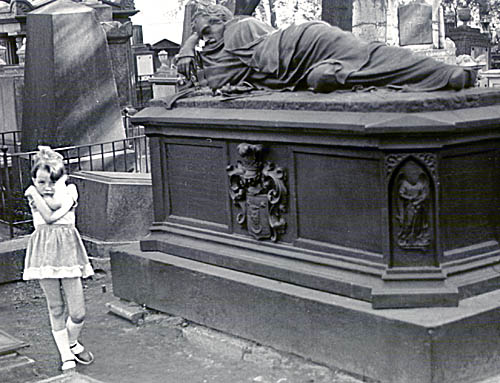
[191,0,234,44]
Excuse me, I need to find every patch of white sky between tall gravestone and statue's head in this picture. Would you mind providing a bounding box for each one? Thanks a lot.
[132,0,183,44]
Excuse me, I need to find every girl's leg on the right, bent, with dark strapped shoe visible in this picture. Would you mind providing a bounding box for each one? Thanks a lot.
[61,278,94,364]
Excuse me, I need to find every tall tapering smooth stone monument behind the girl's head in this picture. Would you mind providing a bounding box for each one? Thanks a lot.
[22,0,125,151]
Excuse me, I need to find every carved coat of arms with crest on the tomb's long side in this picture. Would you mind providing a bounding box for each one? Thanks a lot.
[226,143,288,241]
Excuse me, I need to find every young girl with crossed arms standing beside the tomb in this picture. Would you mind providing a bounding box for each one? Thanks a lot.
[23,146,94,371]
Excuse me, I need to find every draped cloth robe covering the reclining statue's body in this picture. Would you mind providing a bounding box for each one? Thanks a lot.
[201,17,457,91]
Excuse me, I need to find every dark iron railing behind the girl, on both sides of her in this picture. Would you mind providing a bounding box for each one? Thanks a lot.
[0,134,151,238]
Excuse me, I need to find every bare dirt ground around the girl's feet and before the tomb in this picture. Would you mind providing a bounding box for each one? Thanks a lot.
[0,273,368,383]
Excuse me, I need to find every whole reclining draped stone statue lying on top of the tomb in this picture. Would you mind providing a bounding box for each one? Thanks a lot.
[177,3,476,93]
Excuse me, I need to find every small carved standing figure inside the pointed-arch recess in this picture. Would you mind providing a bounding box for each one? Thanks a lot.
[396,161,431,249]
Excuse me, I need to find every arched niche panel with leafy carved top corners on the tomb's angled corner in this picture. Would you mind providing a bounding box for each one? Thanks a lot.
[385,153,438,251]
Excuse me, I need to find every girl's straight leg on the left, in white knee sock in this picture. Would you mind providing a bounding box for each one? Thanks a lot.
[40,279,75,370]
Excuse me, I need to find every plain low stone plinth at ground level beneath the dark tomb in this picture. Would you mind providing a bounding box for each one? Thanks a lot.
[111,245,500,383]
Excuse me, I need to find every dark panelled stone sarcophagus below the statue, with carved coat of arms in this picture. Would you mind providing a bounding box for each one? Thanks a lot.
[128,90,500,308]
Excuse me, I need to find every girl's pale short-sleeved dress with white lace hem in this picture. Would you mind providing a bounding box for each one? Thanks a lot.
[23,185,94,280]
